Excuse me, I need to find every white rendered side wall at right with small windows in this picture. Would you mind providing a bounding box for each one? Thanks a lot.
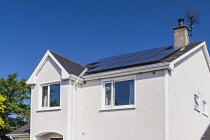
[169,49,210,140]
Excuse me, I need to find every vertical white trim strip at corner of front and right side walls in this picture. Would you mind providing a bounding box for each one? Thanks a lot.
[164,69,169,140]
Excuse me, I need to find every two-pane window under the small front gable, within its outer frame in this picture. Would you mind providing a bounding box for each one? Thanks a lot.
[42,84,60,107]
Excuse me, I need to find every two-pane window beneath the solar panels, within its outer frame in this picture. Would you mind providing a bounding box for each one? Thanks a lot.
[104,80,134,107]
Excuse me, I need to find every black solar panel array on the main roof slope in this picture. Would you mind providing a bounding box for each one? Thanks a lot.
[87,46,175,74]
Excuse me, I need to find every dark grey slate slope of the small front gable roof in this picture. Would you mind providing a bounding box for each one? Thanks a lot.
[49,50,85,76]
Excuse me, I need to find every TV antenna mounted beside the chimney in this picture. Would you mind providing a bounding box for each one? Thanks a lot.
[187,9,200,36]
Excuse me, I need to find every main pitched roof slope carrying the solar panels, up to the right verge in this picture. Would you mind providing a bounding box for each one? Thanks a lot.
[86,41,203,75]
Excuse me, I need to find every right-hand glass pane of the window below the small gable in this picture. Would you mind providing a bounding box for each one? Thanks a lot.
[50,84,60,107]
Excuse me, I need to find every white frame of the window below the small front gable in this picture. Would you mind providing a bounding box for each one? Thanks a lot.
[38,81,61,111]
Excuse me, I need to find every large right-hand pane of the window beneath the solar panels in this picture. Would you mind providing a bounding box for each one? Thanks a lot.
[114,80,134,106]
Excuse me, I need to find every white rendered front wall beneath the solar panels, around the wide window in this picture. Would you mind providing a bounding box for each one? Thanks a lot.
[75,71,165,140]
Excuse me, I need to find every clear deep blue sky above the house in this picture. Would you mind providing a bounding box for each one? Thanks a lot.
[0,0,210,79]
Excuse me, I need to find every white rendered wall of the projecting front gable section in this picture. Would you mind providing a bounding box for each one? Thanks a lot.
[31,58,71,140]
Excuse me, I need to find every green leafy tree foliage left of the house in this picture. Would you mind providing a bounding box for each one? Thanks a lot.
[0,73,30,139]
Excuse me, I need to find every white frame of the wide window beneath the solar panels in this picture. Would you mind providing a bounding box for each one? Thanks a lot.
[100,75,136,111]
